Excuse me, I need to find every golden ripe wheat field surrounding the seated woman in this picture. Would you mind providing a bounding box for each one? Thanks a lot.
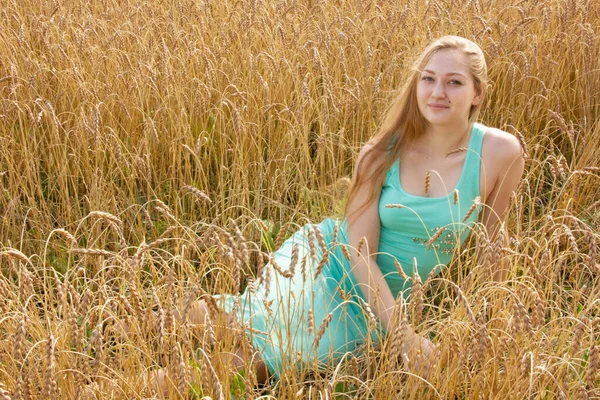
[0,0,600,399]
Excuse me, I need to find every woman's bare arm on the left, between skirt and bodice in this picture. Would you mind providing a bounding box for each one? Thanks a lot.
[348,144,428,368]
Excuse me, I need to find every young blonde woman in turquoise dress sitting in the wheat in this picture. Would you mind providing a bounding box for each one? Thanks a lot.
[185,36,523,380]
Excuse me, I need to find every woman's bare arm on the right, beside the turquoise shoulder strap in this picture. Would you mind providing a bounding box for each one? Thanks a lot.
[481,128,525,280]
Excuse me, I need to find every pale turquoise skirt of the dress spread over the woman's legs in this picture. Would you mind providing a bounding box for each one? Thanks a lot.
[216,218,382,379]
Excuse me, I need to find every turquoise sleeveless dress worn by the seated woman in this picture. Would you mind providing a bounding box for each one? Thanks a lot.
[217,123,485,378]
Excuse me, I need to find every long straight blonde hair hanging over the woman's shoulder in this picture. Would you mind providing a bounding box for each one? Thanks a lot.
[346,36,487,222]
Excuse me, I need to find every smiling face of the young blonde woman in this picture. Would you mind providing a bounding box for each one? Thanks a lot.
[417,49,481,127]
